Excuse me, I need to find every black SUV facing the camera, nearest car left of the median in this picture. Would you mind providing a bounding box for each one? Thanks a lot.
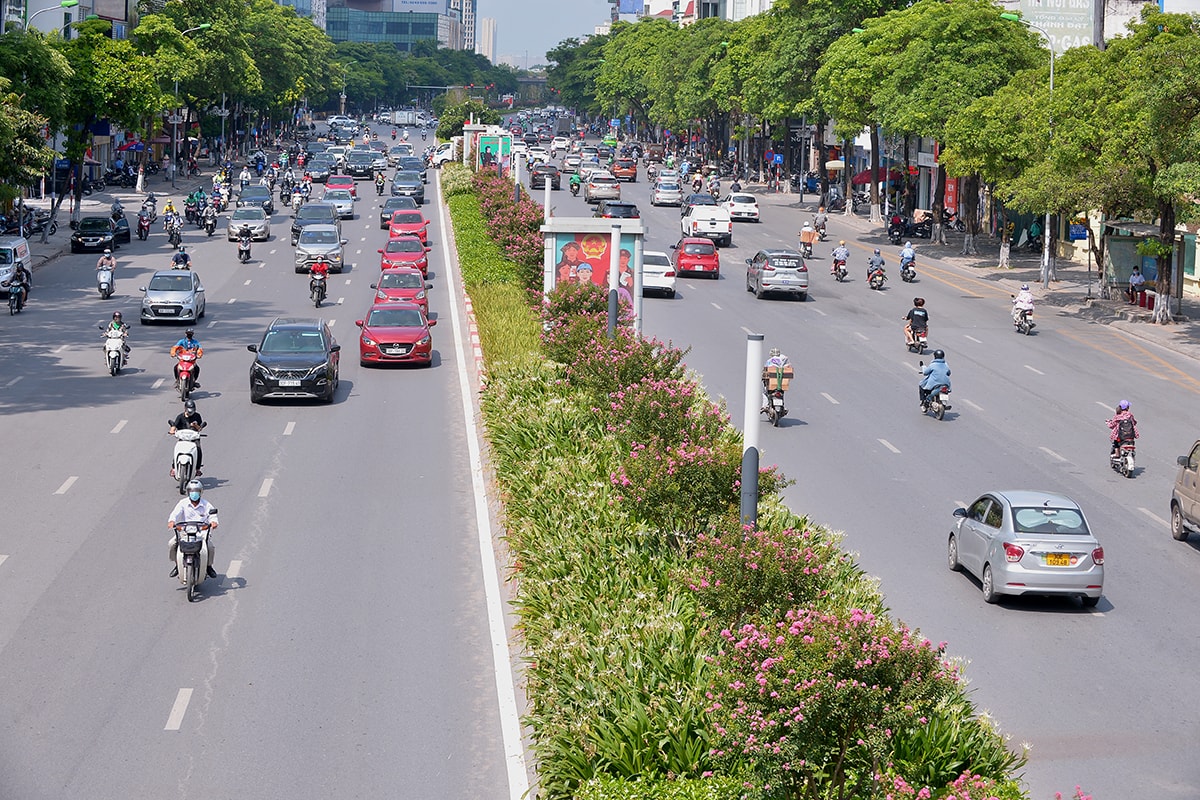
[246,317,342,403]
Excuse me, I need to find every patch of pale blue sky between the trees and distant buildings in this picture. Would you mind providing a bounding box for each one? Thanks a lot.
[475,0,612,68]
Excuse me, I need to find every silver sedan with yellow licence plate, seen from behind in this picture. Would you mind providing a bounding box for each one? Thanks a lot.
[946,491,1104,607]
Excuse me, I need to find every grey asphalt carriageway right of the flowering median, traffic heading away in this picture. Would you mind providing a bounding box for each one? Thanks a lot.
[544,153,1200,799]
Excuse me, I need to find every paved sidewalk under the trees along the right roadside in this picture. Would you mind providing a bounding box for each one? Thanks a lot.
[745,184,1200,360]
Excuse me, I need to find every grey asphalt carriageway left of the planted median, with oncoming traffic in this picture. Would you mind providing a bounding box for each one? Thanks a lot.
[0,125,509,800]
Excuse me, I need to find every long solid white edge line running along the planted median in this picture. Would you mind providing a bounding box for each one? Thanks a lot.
[436,175,529,800]
